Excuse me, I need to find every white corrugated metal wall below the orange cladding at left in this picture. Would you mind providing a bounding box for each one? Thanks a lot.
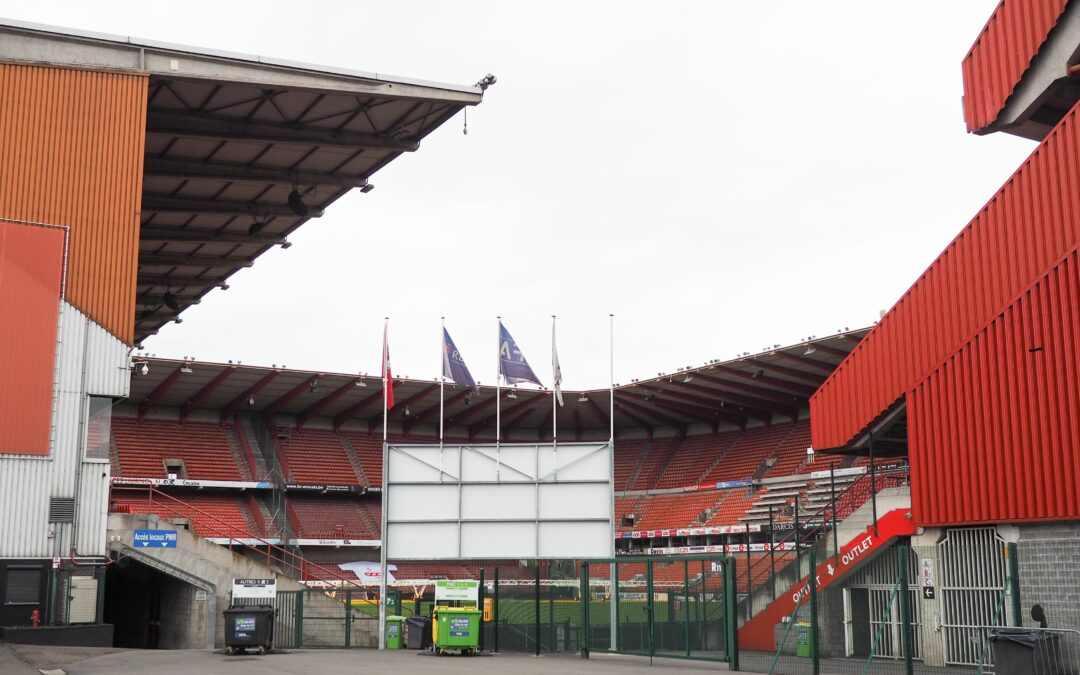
[0,302,131,557]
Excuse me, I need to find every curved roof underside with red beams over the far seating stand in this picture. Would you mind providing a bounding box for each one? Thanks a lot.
[131,328,868,441]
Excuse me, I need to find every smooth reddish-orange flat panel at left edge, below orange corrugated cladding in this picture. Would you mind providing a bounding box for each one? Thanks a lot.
[0,222,64,455]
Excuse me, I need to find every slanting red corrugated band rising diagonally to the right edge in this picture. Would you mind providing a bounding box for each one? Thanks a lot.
[810,98,1080,449]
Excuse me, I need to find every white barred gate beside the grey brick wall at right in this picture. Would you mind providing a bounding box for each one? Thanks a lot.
[937,527,1008,666]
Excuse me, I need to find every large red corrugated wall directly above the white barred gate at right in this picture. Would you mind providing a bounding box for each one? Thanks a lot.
[907,249,1080,526]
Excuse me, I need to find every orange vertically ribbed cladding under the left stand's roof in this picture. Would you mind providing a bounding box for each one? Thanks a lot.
[0,64,147,345]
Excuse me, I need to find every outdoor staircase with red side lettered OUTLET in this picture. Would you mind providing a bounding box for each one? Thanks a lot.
[735,471,915,651]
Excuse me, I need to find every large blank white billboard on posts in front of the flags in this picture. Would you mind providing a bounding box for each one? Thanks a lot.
[382,442,615,561]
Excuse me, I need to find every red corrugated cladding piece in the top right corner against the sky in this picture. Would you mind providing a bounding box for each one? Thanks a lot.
[963,0,1068,132]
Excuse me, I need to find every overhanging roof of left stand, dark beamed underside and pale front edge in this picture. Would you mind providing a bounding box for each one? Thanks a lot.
[0,19,483,341]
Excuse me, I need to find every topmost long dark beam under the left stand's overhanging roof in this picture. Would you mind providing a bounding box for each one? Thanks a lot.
[146,109,420,152]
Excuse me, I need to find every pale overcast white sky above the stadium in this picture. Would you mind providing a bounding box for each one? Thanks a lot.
[6,0,1035,388]
